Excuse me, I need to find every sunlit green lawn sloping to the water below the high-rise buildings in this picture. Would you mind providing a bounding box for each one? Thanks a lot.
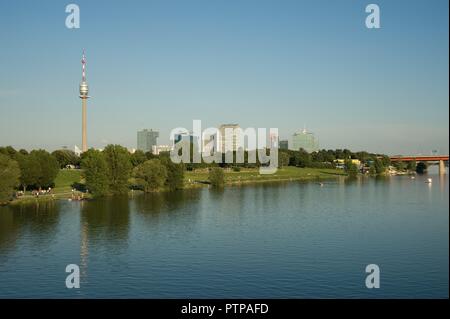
[185,166,345,184]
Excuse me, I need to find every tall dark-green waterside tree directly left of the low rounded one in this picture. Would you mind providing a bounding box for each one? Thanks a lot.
[103,145,132,194]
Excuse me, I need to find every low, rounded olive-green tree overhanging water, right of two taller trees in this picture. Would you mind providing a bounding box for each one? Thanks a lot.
[133,159,167,192]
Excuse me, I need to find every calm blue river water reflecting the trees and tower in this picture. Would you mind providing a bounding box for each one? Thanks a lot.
[0,171,449,298]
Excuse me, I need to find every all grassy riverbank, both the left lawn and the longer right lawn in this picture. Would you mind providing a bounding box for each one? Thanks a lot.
[11,166,345,204]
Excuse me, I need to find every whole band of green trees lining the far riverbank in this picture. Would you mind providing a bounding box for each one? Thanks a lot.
[0,145,402,204]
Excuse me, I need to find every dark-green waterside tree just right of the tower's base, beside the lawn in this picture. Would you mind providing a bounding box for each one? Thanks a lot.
[81,149,109,197]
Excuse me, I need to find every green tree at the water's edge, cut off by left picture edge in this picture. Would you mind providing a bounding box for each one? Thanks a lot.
[0,154,20,204]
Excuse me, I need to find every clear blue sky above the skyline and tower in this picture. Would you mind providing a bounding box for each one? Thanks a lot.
[0,0,449,154]
